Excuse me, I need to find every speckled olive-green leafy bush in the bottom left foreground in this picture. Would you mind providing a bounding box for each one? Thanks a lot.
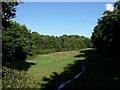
[2,67,35,89]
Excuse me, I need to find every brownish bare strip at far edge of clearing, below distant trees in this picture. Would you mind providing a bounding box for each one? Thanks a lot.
[49,51,80,56]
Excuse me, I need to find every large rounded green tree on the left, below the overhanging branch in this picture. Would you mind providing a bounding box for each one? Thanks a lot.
[2,21,34,62]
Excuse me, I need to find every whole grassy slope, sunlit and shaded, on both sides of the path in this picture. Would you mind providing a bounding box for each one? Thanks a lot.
[27,49,120,90]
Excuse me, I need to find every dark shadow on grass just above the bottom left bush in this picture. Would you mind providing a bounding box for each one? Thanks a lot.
[5,60,35,71]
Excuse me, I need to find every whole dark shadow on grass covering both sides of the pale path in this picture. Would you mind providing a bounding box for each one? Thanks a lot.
[42,50,120,90]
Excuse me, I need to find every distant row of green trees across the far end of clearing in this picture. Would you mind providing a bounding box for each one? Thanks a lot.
[32,32,91,54]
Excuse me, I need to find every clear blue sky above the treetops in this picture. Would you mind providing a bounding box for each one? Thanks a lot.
[13,2,115,37]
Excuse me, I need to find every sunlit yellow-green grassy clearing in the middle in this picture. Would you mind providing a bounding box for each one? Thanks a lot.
[27,51,84,88]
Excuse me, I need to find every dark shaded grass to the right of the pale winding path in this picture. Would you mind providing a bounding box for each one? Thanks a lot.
[63,50,120,90]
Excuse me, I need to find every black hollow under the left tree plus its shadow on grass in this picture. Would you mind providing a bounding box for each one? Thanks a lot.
[2,46,35,71]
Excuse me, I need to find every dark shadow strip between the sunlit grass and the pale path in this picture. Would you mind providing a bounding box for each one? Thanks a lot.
[41,50,96,90]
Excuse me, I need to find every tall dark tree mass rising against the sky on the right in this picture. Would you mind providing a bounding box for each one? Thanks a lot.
[91,1,120,50]
